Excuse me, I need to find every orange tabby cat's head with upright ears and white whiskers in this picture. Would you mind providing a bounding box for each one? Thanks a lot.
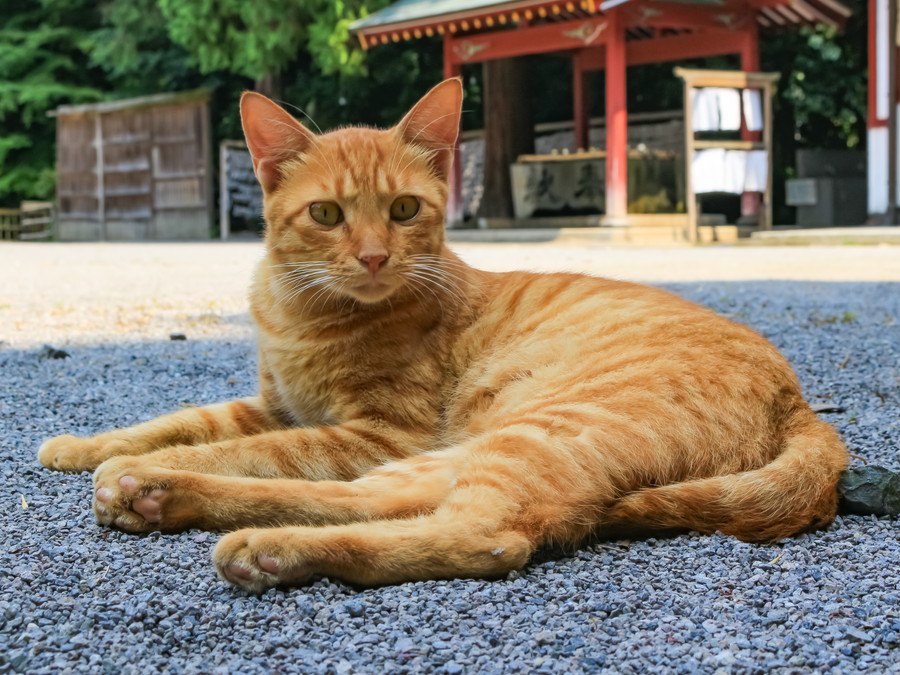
[241,78,462,303]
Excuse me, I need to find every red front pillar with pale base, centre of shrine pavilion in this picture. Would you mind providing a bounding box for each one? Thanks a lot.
[606,8,628,218]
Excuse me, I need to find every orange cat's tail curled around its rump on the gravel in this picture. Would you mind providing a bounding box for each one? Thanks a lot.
[601,407,848,542]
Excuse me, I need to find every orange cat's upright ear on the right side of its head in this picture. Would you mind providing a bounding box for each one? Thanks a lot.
[397,77,462,178]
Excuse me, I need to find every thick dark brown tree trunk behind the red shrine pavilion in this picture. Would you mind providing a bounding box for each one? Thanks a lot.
[477,58,534,218]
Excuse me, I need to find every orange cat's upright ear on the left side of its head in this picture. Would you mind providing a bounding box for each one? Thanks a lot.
[241,91,315,192]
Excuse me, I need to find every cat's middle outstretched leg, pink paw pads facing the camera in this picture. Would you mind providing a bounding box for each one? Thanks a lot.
[94,450,460,532]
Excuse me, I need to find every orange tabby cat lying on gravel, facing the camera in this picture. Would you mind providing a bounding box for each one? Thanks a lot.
[39,79,847,591]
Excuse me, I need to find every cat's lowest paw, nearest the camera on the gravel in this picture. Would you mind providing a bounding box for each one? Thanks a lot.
[213,529,314,593]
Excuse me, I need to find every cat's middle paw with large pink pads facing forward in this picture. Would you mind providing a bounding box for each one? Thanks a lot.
[93,457,190,532]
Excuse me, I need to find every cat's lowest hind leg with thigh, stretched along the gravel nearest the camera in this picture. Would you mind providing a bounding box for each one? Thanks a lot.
[213,426,611,592]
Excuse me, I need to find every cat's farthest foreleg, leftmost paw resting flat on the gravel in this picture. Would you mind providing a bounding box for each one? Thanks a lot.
[38,397,281,471]
